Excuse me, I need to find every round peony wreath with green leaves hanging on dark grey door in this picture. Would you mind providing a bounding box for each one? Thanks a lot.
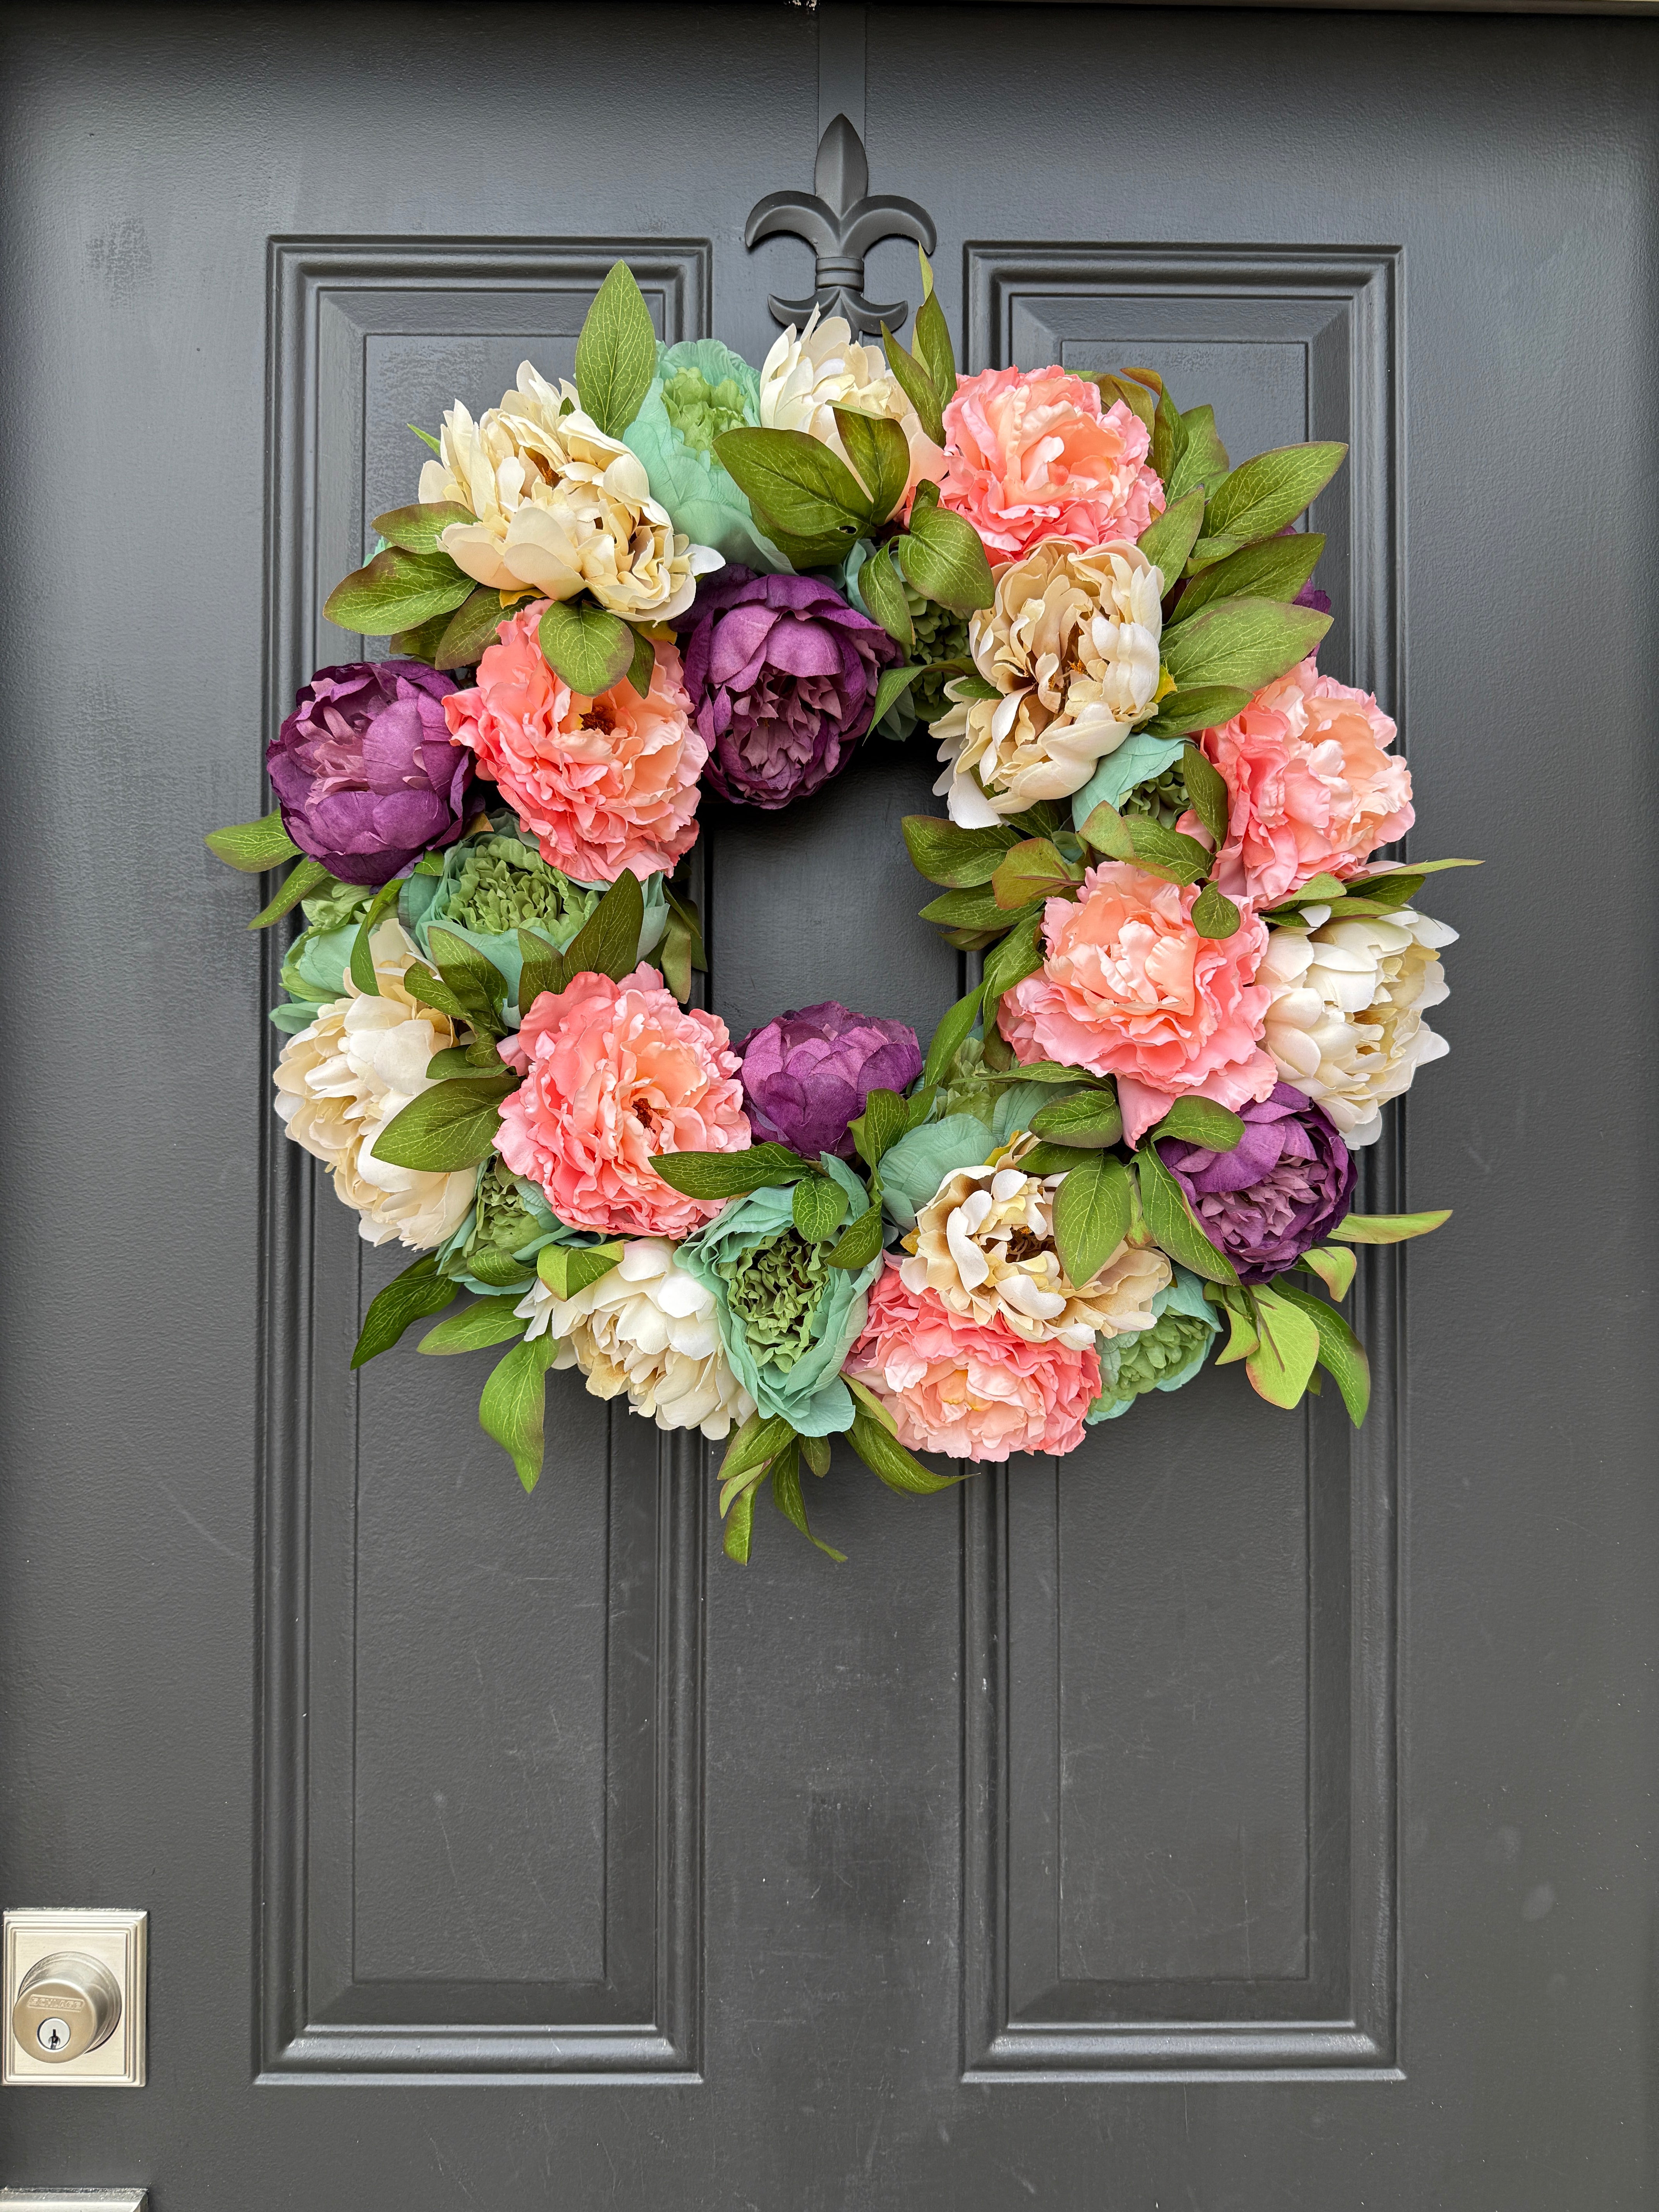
[208,259,1471,1559]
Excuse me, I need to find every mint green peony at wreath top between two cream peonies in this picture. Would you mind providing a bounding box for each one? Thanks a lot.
[622,338,790,575]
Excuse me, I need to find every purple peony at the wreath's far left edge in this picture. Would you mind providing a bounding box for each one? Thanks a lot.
[265,661,473,885]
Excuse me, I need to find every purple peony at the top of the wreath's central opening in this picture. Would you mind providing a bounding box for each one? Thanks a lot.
[686,564,898,807]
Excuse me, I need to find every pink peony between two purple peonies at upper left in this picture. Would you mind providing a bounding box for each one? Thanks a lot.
[445,599,708,883]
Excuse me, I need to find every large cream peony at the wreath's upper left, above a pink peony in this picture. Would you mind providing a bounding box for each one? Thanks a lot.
[420,361,726,622]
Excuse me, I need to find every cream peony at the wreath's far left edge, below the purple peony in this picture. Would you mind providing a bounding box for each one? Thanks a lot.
[276,922,478,1252]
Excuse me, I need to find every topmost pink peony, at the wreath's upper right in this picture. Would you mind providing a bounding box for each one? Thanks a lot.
[940,369,1164,562]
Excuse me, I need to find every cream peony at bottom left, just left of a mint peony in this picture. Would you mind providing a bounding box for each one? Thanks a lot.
[513,1237,754,1438]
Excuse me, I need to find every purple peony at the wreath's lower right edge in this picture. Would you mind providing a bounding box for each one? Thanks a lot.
[1159,1084,1356,1283]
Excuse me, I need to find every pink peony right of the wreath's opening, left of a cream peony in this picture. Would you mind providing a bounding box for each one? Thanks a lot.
[998,860,1279,1144]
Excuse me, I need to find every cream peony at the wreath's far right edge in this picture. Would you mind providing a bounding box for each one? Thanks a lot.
[1256,907,1458,1150]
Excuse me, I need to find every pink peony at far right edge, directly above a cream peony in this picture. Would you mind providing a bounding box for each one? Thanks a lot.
[1181,653,1416,907]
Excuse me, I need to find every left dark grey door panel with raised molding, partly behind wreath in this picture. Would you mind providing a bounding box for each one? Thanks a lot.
[257,239,710,2084]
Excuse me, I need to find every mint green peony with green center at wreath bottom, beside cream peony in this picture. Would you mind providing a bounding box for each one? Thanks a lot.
[675,1152,883,1436]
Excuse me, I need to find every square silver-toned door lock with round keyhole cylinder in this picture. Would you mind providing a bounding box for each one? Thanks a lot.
[0,1907,146,2079]
